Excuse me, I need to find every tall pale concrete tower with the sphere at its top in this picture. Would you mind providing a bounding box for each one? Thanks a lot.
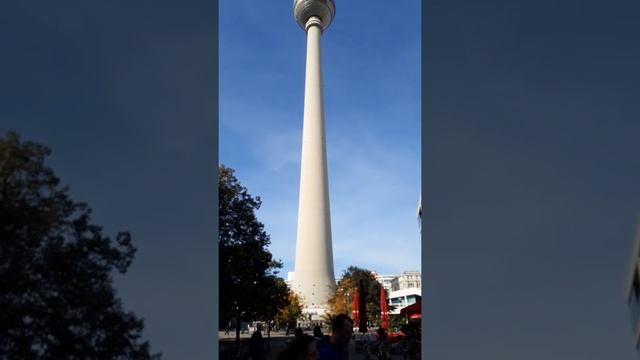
[292,0,335,309]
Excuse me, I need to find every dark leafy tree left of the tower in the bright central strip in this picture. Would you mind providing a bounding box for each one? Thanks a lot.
[218,165,288,342]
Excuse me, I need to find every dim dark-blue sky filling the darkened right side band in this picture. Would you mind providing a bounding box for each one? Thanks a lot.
[422,0,640,360]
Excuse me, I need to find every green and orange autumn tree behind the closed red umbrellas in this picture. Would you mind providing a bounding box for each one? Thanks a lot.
[329,266,388,321]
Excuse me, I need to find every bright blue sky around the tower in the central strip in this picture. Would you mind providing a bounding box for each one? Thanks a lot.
[219,1,421,277]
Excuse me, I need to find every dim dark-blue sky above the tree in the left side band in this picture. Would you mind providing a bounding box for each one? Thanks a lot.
[0,0,217,359]
